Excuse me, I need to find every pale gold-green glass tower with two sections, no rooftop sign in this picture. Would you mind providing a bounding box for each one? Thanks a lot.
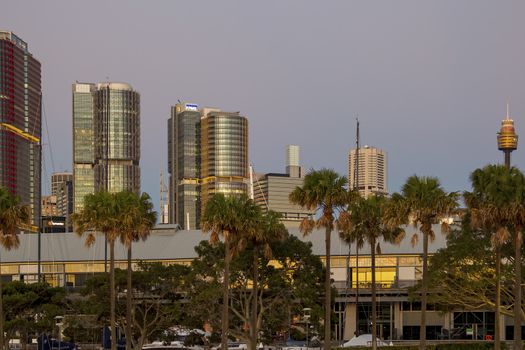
[73,82,140,211]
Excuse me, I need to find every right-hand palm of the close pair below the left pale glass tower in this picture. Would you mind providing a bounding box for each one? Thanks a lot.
[116,192,157,349]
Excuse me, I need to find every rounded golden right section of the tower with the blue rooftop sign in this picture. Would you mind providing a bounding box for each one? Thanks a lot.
[200,109,249,216]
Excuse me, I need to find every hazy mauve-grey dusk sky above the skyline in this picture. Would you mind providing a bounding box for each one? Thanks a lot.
[0,0,525,211]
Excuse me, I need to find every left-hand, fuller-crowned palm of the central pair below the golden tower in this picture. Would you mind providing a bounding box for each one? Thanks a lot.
[201,193,257,350]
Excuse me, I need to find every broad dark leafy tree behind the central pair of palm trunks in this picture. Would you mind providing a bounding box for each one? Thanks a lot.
[186,235,324,342]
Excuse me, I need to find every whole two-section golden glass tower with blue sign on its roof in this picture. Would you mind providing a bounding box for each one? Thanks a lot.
[168,102,248,229]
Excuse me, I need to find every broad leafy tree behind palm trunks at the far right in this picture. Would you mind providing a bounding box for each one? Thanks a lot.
[424,213,514,322]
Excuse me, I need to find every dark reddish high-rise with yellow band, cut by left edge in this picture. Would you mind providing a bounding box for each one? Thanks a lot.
[0,31,42,231]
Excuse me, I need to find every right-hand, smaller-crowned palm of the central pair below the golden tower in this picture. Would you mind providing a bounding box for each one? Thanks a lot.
[238,211,287,350]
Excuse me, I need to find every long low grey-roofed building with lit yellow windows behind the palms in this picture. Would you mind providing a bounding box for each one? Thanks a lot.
[0,225,512,340]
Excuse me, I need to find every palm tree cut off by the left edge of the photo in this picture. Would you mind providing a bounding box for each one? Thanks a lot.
[0,187,31,350]
